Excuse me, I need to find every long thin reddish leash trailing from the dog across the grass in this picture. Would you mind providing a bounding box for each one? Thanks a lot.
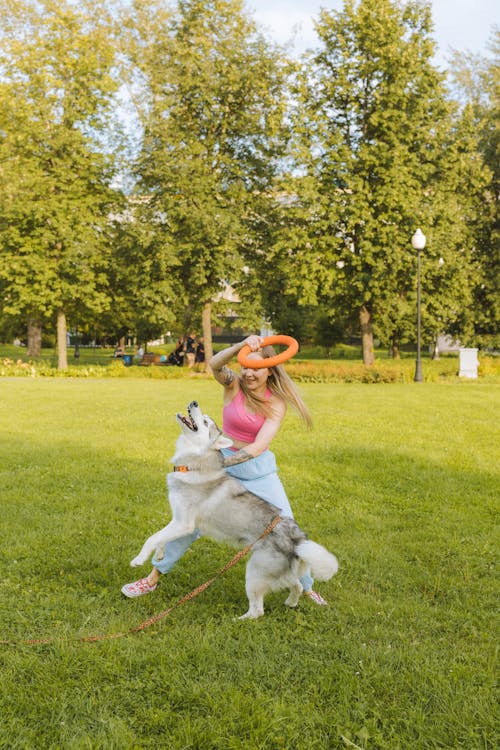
[0,516,281,646]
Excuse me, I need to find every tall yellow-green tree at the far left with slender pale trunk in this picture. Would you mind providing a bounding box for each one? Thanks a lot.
[0,0,117,368]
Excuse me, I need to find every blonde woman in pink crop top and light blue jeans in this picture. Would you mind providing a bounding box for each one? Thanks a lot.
[122,336,327,605]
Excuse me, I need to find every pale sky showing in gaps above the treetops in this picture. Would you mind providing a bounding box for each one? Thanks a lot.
[246,0,500,67]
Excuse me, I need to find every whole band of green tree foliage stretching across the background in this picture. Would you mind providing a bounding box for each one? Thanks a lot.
[0,0,494,364]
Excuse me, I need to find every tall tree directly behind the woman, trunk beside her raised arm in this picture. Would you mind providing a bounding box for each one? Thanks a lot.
[121,0,292,358]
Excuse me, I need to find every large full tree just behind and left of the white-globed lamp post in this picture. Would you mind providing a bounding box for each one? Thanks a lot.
[278,0,484,364]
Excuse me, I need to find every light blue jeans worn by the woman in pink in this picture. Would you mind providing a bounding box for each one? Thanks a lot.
[152,448,313,591]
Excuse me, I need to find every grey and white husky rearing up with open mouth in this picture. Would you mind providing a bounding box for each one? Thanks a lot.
[130,401,338,619]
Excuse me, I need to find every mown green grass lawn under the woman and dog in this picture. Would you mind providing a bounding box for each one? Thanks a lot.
[0,378,500,750]
